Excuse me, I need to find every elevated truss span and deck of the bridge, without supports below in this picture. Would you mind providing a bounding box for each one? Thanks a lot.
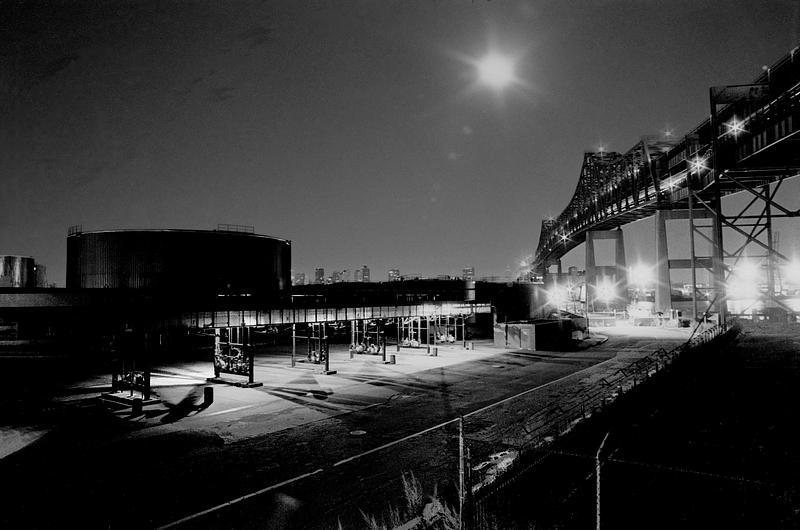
[533,48,800,280]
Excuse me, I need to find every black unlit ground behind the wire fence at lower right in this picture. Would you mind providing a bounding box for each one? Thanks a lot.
[490,323,800,529]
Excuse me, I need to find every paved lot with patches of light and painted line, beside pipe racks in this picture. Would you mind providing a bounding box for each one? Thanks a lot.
[0,328,688,528]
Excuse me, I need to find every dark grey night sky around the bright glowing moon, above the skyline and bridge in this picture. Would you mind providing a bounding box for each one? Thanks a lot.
[0,0,800,286]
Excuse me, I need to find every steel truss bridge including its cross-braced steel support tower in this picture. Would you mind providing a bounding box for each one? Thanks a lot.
[532,47,800,318]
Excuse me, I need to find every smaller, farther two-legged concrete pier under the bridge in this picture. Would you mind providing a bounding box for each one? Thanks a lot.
[586,228,628,311]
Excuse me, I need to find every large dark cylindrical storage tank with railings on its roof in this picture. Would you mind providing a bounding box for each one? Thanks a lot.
[67,230,291,295]
